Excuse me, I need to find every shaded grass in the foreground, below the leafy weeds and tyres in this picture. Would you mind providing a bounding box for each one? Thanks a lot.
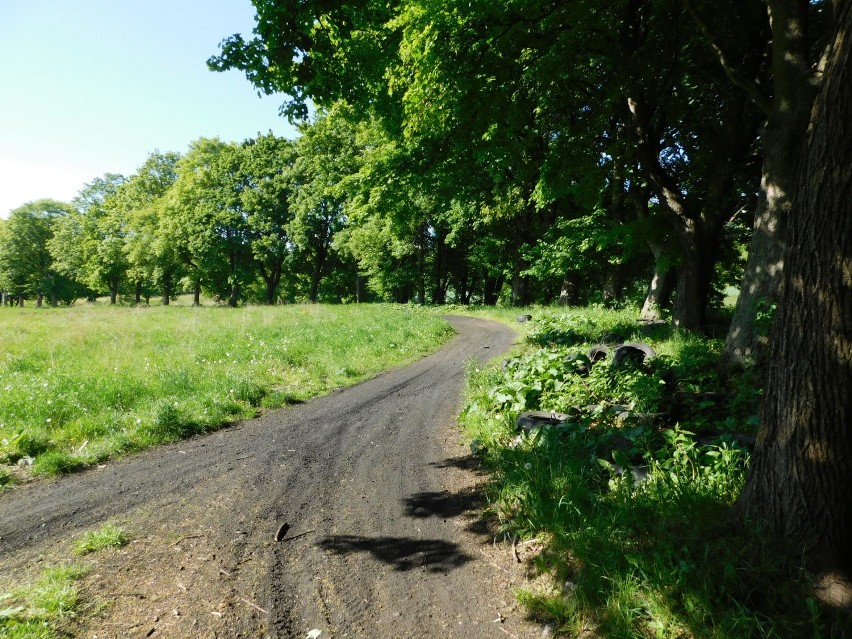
[480,430,848,639]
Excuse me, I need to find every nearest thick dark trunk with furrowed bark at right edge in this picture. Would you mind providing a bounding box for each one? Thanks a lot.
[739,3,852,609]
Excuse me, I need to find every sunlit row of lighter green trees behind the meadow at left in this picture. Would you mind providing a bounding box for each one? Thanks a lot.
[0,118,356,306]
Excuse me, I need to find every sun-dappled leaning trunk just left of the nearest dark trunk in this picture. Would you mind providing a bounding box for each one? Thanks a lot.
[720,0,815,369]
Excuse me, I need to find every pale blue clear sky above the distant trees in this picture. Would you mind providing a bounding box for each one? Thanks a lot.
[0,0,296,217]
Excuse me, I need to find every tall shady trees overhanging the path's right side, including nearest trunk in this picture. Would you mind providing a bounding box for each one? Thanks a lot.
[209,0,852,608]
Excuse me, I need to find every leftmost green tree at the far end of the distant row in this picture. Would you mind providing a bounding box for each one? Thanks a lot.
[0,200,73,306]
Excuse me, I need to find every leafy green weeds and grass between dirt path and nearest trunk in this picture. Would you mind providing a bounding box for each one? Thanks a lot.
[462,310,845,639]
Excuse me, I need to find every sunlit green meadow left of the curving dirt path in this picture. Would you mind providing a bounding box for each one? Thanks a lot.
[0,305,451,478]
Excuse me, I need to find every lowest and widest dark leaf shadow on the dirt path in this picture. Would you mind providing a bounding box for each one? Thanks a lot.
[318,535,472,573]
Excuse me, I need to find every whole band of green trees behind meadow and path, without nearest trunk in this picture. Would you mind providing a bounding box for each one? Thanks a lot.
[0,0,830,350]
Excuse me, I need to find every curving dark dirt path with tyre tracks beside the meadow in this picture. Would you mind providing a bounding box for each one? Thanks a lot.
[0,318,542,639]
